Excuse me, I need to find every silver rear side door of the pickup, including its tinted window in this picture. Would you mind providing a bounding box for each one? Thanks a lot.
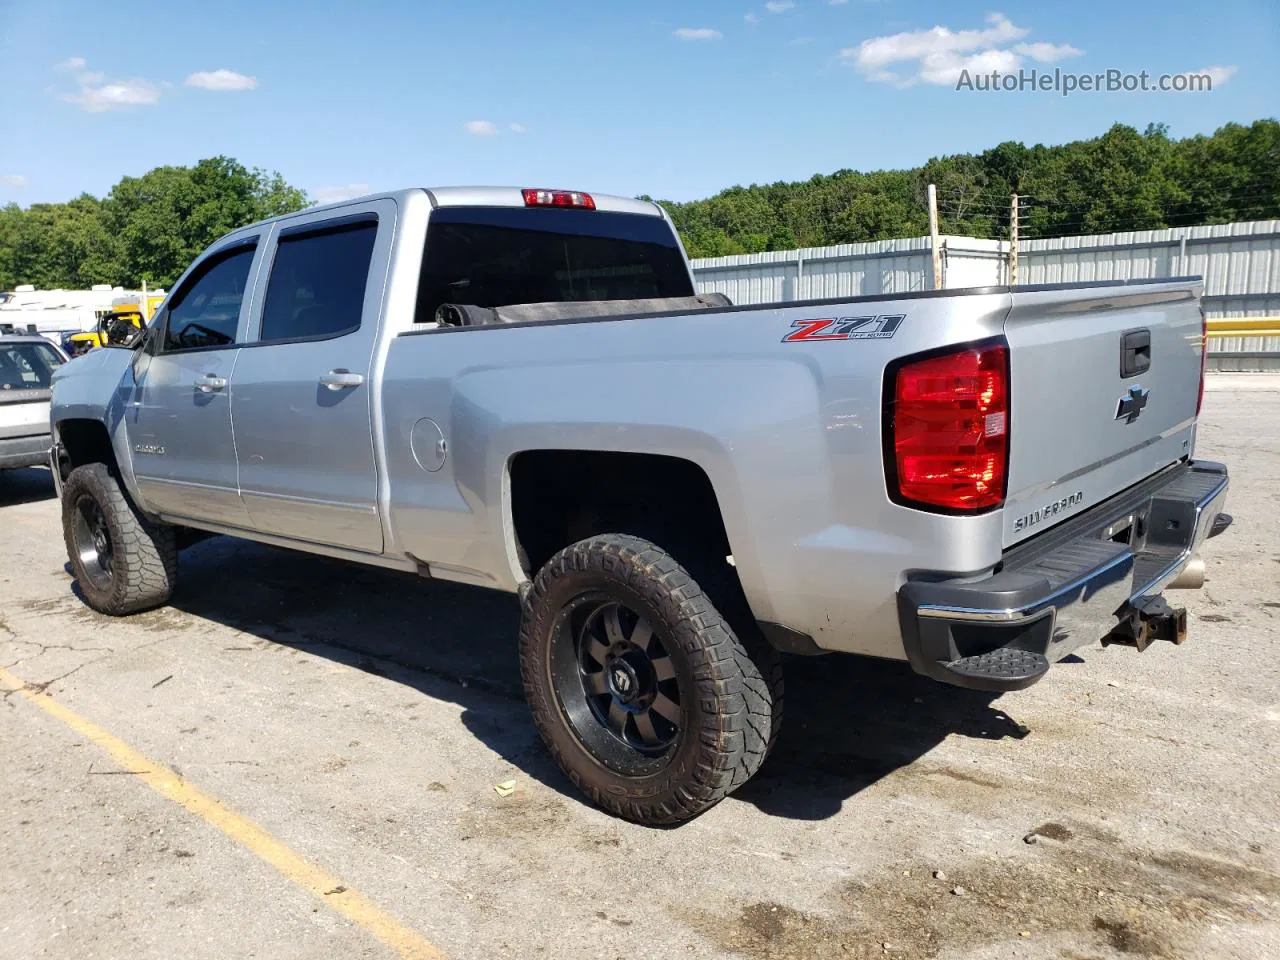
[232,201,396,553]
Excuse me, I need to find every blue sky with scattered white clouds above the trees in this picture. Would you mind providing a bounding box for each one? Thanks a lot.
[0,0,1280,206]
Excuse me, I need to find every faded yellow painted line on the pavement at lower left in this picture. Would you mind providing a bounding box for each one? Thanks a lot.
[0,668,445,960]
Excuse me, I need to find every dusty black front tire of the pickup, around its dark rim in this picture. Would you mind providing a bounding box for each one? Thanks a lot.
[63,463,178,617]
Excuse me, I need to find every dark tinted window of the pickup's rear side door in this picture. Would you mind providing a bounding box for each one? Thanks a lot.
[260,220,378,343]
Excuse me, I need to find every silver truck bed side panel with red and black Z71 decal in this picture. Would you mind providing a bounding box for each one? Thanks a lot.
[383,294,1009,658]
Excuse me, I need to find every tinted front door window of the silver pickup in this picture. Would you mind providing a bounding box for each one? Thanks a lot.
[164,246,255,351]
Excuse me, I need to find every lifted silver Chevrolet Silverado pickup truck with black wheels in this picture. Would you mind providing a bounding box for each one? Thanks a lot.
[51,188,1230,823]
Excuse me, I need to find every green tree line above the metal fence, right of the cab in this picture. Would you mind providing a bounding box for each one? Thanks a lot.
[659,119,1280,257]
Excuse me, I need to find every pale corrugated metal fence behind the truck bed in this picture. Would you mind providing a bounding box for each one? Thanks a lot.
[694,220,1280,369]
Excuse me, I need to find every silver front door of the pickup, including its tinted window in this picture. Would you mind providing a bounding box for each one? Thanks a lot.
[125,238,257,527]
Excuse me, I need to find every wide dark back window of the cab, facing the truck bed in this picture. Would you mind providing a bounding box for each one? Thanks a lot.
[415,207,694,323]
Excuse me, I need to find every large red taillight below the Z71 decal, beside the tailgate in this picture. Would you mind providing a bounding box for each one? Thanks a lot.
[886,344,1009,511]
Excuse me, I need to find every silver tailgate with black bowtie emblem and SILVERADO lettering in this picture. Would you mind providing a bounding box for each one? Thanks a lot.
[1004,280,1204,547]
